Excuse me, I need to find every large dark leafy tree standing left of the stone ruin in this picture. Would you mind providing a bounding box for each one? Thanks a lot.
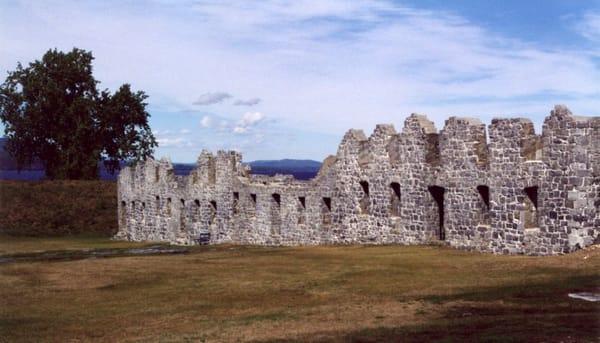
[0,48,157,179]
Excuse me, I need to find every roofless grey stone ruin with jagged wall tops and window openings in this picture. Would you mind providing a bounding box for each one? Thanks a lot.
[117,106,600,255]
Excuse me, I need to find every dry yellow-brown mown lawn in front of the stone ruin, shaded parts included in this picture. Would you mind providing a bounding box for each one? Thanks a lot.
[0,237,600,342]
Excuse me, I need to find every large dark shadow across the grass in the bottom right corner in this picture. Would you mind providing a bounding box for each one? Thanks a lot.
[260,275,600,342]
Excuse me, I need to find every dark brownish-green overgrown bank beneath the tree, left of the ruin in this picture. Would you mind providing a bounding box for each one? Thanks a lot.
[0,181,118,236]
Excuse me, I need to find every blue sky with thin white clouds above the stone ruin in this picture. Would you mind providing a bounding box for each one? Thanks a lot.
[0,0,600,162]
